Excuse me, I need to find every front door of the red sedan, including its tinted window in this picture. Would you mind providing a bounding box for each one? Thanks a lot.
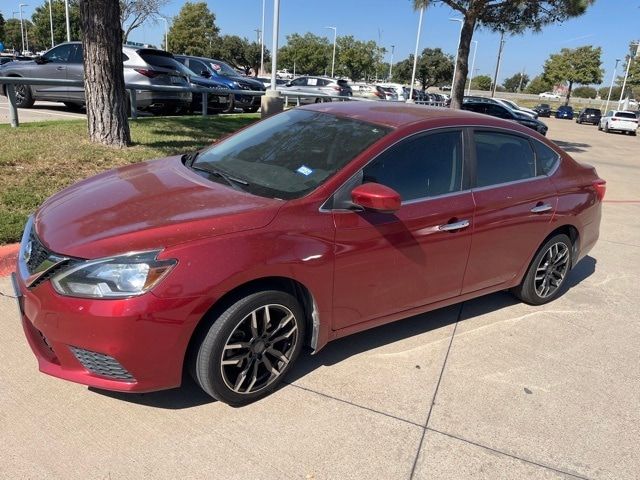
[333,130,474,330]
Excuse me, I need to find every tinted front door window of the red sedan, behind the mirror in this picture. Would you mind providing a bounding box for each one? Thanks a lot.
[363,132,462,201]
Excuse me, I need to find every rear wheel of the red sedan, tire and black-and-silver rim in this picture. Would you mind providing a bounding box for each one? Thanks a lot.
[513,234,573,305]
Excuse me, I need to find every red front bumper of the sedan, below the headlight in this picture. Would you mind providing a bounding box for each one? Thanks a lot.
[12,268,198,392]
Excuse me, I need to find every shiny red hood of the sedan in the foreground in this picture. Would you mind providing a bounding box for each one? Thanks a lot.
[35,157,283,258]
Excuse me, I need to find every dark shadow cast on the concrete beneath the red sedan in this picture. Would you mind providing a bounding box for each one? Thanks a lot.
[88,256,597,410]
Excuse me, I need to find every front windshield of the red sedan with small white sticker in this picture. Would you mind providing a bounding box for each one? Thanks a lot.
[193,109,390,200]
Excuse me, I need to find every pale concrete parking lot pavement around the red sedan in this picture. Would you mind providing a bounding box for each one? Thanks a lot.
[0,117,640,480]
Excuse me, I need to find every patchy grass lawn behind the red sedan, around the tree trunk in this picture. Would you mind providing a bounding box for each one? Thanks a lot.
[0,114,259,245]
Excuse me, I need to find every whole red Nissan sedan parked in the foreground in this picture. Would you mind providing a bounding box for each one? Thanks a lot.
[13,102,605,405]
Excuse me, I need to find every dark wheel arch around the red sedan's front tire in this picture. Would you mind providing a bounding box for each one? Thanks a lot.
[184,276,320,374]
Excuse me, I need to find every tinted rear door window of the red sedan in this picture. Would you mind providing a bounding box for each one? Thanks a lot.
[474,132,536,187]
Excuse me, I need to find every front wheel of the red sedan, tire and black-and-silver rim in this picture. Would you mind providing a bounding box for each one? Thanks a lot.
[192,290,305,405]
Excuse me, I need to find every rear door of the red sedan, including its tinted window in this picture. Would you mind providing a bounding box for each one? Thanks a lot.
[462,129,558,293]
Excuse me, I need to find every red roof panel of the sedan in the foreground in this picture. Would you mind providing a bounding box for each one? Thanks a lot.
[300,101,535,134]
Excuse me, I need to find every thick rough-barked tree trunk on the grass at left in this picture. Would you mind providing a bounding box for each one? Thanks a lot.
[79,0,131,148]
